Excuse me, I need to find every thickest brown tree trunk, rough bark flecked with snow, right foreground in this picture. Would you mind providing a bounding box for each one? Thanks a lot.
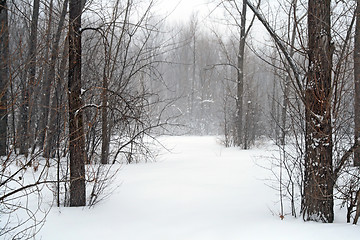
[302,0,334,223]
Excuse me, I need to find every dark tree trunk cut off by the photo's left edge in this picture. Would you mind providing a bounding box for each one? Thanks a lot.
[0,0,9,156]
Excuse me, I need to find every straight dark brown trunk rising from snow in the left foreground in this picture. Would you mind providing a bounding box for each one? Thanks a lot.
[68,0,86,206]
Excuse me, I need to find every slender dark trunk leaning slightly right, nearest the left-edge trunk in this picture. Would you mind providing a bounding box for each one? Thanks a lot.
[20,0,40,156]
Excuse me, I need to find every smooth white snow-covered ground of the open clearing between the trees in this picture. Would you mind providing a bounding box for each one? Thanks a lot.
[38,137,360,240]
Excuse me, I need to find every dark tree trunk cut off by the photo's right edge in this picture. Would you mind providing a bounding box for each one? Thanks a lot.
[354,0,360,166]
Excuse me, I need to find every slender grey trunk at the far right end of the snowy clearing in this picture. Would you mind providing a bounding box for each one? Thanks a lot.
[236,0,247,146]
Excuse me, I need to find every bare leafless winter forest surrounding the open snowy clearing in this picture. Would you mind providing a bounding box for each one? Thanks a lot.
[0,0,360,239]
